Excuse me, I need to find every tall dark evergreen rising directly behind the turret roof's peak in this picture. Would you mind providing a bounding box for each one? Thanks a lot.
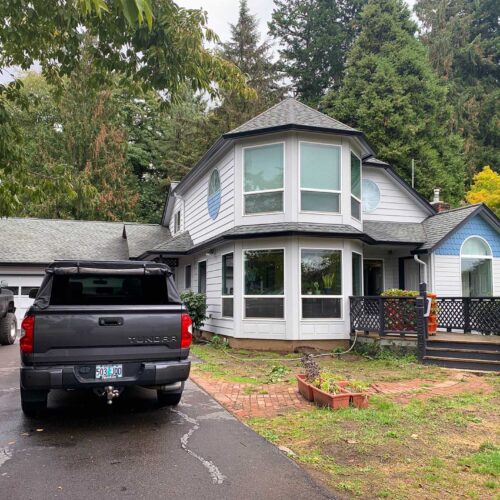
[269,0,366,106]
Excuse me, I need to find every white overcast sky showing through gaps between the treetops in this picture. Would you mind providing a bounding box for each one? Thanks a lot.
[0,0,415,83]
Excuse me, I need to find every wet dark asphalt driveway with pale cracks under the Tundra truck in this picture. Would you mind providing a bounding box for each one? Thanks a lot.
[0,345,332,500]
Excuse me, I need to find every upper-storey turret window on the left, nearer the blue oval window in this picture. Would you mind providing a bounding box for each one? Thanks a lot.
[243,143,284,214]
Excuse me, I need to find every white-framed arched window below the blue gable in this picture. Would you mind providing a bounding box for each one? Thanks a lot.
[460,236,493,297]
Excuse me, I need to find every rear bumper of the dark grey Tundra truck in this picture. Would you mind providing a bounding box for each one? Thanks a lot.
[21,360,191,390]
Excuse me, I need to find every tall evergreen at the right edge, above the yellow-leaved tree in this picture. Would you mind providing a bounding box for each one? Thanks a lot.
[415,0,500,176]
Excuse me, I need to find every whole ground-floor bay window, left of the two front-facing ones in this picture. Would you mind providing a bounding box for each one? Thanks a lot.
[243,249,285,318]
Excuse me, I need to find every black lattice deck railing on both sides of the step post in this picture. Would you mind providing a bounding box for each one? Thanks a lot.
[349,296,500,336]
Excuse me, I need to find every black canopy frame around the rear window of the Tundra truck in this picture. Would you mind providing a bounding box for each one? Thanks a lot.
[33,260,181,309]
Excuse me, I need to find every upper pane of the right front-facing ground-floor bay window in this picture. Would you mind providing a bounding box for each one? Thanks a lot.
[301,250,342,295]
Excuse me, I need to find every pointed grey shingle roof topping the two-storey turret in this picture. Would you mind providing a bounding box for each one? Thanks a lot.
[224,98,359,137]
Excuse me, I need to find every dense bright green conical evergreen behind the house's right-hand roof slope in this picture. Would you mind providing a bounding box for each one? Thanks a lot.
[323,0,465,203]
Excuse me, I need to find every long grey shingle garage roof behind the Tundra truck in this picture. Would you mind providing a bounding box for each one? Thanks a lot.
[0,218,128,264]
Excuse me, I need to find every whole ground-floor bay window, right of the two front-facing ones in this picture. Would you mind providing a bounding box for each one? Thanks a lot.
[300,249,342,319]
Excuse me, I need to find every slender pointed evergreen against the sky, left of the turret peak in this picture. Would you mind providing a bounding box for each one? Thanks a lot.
[205,0,284,141]
